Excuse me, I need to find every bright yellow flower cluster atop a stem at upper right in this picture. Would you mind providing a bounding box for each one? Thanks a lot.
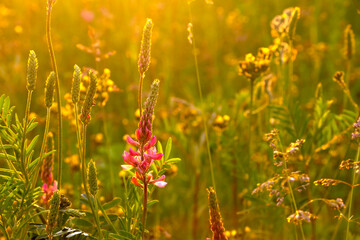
[239,48,271,81]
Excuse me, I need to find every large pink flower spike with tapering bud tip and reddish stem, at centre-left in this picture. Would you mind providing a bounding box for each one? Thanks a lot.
[121,80,167,239]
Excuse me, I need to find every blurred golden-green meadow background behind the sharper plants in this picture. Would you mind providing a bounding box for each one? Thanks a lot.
[0,0,360,239]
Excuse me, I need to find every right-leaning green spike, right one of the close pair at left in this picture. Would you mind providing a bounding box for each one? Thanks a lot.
[80,71,97,124]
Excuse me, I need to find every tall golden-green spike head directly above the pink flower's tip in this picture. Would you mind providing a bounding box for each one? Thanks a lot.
[138,18,153,75]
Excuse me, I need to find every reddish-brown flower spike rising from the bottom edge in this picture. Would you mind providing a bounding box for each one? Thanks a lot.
[207,187,227,240]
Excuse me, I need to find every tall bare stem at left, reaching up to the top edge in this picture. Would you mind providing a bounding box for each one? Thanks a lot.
[46,1,63,191]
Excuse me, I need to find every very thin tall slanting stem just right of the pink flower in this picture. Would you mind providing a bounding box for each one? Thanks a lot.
[188,2,216,191]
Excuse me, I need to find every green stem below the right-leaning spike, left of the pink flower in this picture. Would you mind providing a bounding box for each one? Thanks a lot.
[79,123,103,239]
